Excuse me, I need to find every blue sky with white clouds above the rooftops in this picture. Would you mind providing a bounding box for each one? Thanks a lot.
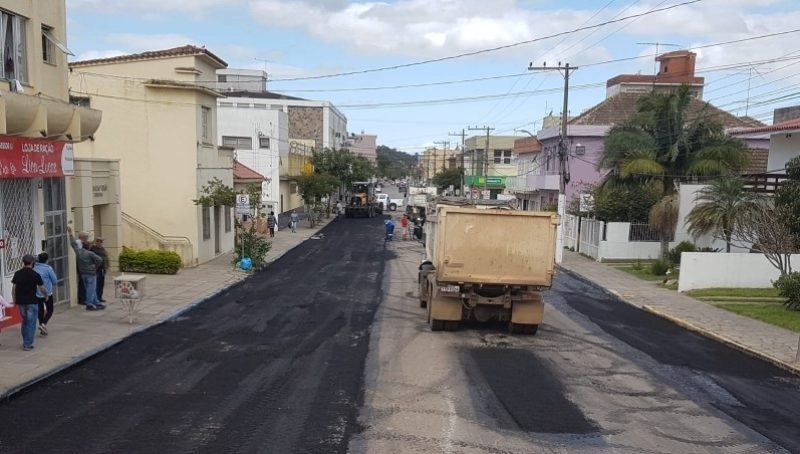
[66,0,800,154]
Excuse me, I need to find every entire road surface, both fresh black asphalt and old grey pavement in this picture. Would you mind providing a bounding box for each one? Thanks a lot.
[0,213,800,454]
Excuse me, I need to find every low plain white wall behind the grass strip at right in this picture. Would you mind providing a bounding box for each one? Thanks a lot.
[678,252,800,292]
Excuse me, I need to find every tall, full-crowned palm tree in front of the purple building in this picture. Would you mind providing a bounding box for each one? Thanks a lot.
[598,85,748,257]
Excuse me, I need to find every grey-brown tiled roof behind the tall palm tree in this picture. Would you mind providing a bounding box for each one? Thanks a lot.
[569,93,764,128]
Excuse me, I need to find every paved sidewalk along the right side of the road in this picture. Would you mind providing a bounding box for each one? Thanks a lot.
[560,251,800,375]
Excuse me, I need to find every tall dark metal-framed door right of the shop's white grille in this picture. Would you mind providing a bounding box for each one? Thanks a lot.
[42,178,70,304]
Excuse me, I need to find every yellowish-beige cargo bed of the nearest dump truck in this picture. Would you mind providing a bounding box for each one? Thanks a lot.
[426,205,558,287]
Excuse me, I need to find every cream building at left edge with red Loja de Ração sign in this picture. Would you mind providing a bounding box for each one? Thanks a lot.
[0,0,102,327]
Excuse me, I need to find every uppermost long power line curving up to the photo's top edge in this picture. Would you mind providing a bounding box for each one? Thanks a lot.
[272,0,703,82]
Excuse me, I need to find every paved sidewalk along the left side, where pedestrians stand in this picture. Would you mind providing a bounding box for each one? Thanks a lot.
[0,217,335,398]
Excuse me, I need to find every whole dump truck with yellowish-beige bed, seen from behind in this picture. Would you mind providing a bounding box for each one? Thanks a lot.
[419,198,559,334]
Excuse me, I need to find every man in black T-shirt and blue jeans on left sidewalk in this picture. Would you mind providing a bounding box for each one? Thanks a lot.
[11,254,47,351]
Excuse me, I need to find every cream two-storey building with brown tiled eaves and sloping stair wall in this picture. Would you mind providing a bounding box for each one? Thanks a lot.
[69,46,234,266]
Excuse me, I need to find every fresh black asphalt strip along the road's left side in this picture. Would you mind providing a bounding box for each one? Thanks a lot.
[0,218,389,454]
